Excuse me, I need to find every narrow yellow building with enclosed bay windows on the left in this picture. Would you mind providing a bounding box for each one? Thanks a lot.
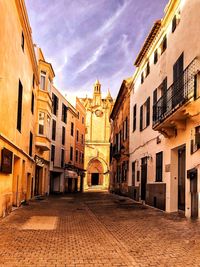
[34,47,55,195]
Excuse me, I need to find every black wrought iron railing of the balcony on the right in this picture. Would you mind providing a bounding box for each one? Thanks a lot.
[153,58,200,127]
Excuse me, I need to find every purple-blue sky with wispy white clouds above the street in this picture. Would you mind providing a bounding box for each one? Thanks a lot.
[25,0,168,101]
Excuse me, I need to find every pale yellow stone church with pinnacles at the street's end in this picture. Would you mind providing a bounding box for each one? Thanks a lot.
[80,80,114,190]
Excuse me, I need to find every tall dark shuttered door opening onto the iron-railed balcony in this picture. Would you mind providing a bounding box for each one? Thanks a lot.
[172,53,184,108]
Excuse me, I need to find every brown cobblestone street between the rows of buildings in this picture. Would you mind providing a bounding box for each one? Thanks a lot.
[0,192,200,267]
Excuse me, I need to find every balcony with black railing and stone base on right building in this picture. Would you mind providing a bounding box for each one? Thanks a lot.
[153,58,200,137]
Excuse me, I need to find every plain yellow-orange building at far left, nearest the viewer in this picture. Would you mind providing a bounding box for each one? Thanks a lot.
[0,0,39,216]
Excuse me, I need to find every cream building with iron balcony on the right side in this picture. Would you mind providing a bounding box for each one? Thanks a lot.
[128,0,200,217]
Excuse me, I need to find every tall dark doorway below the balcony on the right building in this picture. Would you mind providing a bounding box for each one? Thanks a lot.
[178,147,186,210]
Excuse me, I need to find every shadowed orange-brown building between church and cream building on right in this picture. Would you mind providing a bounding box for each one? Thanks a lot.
[110,78,132,195]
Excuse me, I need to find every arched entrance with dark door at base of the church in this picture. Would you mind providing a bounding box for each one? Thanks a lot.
[87,159,104,186]
